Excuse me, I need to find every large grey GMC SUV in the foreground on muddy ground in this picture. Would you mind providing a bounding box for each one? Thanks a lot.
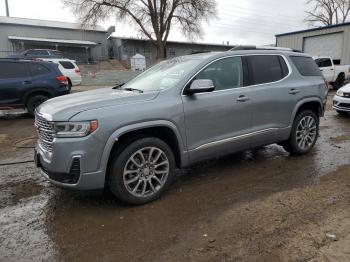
[35,50,327,204]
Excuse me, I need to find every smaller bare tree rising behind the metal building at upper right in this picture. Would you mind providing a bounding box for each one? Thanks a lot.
[305,0,350,26]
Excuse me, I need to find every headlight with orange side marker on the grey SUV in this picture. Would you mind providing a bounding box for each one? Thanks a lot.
[54,120,98,137]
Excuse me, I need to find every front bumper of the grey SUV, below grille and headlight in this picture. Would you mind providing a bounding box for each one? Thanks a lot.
[34,141,105,190]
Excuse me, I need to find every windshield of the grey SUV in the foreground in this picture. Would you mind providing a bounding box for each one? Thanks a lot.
[122,56,203,92]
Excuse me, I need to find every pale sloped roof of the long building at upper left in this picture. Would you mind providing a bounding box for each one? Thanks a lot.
[0,16,107,32]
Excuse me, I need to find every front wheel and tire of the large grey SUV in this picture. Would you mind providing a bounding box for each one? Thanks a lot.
[109,137,175,205]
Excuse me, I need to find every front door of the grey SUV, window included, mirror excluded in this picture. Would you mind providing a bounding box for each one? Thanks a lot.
[183,57,251,162]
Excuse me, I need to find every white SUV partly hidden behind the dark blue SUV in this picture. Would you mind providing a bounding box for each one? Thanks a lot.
[43,58,82,90]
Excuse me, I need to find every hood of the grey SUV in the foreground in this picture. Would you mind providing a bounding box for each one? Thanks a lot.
[37,88,159,121]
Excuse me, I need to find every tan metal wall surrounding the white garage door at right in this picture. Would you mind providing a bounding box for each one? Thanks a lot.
[276,25,350,64]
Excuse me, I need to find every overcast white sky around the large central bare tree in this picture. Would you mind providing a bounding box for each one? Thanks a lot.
[0,0,307,45]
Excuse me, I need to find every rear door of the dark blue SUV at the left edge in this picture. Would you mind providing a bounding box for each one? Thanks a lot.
[0,61,32,106]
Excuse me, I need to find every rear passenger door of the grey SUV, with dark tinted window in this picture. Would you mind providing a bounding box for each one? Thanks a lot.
[245,55,303,146]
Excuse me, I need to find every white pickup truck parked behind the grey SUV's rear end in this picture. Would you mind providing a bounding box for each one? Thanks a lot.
[314,57,350,89]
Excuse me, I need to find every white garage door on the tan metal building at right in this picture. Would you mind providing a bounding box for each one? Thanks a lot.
[304,33,344,59]
